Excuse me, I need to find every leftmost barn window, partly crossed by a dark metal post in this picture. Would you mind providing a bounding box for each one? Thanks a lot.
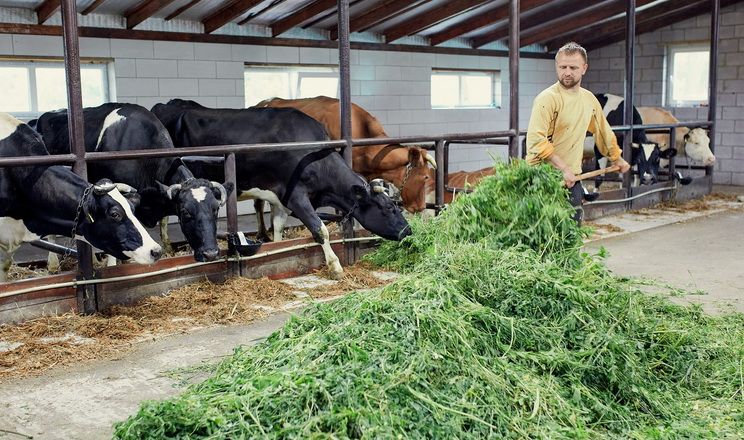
[0,60,110,119]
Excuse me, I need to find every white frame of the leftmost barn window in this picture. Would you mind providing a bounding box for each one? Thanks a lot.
[0,57,115,120]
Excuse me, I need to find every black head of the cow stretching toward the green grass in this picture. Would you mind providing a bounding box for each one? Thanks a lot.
[351,178,411,240]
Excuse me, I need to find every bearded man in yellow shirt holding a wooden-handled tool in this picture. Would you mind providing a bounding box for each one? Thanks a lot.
[526,42,630,223]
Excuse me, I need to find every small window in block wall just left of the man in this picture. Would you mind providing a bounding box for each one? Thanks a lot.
[431,69,501,108]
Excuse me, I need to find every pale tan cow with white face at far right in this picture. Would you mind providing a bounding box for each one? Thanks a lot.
[638,107,716,167]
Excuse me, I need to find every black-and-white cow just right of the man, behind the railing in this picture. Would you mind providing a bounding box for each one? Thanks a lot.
[594,93,676,184]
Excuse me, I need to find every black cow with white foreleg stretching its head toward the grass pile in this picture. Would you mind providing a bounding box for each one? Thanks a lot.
[152,99,411,276]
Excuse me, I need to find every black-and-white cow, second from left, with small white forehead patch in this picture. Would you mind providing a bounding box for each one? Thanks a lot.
[35,103,232,261]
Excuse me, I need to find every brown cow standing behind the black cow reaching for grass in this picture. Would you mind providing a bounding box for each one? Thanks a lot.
[255,96,436,212]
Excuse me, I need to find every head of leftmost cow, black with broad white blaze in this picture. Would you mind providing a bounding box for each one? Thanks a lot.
[76,179,163,264]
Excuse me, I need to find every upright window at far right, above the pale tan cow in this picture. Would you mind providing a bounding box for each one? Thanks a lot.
[665,44,710,107]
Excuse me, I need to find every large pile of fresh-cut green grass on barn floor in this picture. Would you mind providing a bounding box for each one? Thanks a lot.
[115,165,744,439]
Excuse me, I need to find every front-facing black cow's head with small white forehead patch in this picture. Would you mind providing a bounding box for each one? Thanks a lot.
[160,179,233,261]
